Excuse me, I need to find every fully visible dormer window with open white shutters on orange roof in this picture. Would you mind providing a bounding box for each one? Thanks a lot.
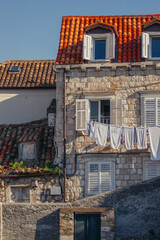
[83,33,115,61]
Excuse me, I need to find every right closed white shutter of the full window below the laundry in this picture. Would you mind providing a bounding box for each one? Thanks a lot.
[100,163,112,193]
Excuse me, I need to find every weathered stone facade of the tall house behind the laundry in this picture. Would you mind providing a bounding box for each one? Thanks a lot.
[55,62,160,200]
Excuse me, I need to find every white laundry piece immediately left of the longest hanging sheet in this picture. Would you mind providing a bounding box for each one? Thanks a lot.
[136,127,147,149]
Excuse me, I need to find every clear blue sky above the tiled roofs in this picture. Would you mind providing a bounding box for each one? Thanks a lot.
[0,0,160,62]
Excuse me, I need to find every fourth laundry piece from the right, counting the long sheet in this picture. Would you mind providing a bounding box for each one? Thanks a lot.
[110,125,122,149]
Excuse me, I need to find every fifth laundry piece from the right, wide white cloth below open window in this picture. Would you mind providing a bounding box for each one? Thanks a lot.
[95,123,108,147]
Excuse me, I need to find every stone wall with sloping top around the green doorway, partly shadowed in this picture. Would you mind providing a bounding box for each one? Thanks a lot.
[0,177,160,240]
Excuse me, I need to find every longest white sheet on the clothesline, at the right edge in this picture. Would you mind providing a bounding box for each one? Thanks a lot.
[148,127,160,160]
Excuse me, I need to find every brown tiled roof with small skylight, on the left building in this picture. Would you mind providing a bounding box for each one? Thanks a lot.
[0,60,55,88]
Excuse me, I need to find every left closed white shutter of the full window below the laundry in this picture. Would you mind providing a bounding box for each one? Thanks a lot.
[88,163,99,195]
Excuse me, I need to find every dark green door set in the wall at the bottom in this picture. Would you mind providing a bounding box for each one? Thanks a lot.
[74,213,100,240]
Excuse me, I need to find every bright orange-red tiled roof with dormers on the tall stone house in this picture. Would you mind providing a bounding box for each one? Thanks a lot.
[56,14,160,64]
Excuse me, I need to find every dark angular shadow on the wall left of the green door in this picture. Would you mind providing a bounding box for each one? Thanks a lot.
[34,210,59,240]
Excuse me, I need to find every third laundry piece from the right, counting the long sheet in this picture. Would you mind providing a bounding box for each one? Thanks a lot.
[123,127,134,150]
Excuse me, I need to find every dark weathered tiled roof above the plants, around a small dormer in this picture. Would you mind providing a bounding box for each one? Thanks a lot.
[0,118,54,165]
